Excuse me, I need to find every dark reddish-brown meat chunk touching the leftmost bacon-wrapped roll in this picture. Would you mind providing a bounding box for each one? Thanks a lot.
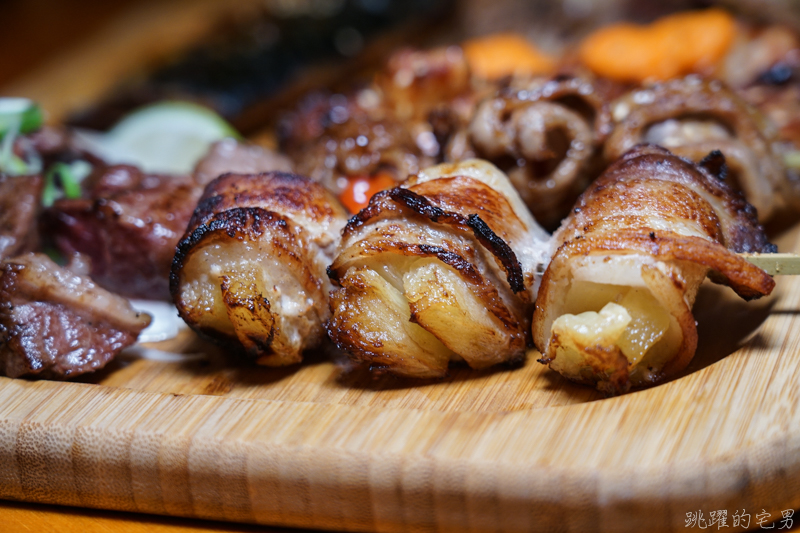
[45,165,201,299]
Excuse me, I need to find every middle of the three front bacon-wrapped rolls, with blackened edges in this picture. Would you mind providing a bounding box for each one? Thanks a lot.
[328,160,548,377]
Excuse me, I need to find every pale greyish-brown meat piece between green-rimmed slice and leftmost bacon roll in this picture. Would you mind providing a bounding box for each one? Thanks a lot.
[193,139,292,187]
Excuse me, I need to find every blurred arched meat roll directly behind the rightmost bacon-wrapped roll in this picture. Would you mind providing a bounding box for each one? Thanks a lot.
[605,76,785,220]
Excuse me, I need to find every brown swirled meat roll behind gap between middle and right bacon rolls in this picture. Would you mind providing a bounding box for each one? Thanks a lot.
[456,76,611,226]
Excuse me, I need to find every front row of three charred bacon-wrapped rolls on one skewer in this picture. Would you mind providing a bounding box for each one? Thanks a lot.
[173,145,775,393]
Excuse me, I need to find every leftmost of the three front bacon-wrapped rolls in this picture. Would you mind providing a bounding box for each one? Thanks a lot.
[170,172,347,366]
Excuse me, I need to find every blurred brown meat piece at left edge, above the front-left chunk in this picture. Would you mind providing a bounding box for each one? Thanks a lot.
[0,173,44,259]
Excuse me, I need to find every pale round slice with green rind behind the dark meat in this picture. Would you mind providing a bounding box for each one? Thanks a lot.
[78,101,241,174]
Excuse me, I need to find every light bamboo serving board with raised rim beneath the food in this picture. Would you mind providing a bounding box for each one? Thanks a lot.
[0,0,800,531]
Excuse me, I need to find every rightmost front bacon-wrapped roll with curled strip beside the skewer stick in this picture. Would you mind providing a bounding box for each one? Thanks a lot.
[533,145,775,393]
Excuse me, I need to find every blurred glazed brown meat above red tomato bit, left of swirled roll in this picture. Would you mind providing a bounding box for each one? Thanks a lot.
[281,47,470,194]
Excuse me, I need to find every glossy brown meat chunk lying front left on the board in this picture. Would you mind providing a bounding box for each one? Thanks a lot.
[0,253,150,378]
